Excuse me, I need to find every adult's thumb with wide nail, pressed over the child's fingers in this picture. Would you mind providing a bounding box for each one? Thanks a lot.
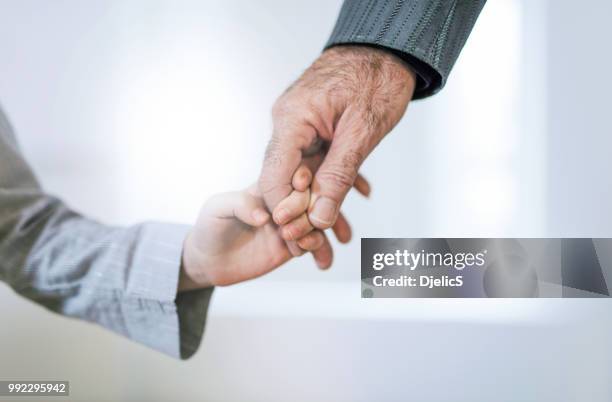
[308,137,365,229]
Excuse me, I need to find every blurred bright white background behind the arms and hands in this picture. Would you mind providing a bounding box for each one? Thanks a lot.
[0,0,612,401]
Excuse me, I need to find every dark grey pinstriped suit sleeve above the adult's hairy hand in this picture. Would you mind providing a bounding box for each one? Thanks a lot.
[326,0,486,99]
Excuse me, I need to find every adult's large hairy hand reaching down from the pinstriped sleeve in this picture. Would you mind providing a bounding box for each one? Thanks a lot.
[259,45,416,254]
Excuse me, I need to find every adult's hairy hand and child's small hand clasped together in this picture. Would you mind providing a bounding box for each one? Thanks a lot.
[179,46,416,289]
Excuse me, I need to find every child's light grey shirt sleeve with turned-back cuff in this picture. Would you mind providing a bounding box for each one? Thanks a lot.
[0,106,212,358]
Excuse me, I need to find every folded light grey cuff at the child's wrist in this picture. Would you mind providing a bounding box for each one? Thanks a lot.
[122,223,213,359]
